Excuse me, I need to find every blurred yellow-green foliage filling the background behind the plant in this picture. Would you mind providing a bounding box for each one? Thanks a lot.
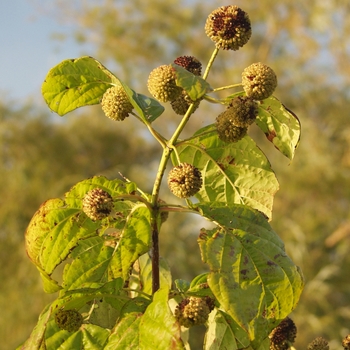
[0,0,350,349]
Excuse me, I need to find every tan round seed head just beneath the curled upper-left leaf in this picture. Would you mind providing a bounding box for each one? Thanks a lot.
[101,86,133,121]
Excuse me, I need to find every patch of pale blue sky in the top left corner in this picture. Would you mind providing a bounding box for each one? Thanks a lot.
[0,0,90,102]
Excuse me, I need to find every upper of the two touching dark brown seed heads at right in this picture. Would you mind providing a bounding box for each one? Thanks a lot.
[227,96,258,127]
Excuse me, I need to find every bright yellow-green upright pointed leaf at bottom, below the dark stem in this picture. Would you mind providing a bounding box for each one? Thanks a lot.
[139,288,184,350]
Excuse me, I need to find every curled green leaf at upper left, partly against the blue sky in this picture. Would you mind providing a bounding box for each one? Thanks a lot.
[41,56,164,122]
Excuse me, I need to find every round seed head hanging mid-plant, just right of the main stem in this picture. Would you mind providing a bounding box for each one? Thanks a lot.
[168,163,202,198]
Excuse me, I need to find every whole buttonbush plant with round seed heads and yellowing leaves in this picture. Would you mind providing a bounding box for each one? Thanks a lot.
[19,6,303,350]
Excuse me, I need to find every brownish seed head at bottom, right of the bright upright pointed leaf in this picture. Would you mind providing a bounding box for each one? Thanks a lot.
[175,297,214,328]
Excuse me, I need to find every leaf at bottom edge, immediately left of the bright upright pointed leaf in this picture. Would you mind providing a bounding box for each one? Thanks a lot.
[104,312,142,350]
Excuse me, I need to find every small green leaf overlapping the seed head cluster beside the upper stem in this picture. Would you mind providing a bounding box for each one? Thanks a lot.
[172,64,213,101]
